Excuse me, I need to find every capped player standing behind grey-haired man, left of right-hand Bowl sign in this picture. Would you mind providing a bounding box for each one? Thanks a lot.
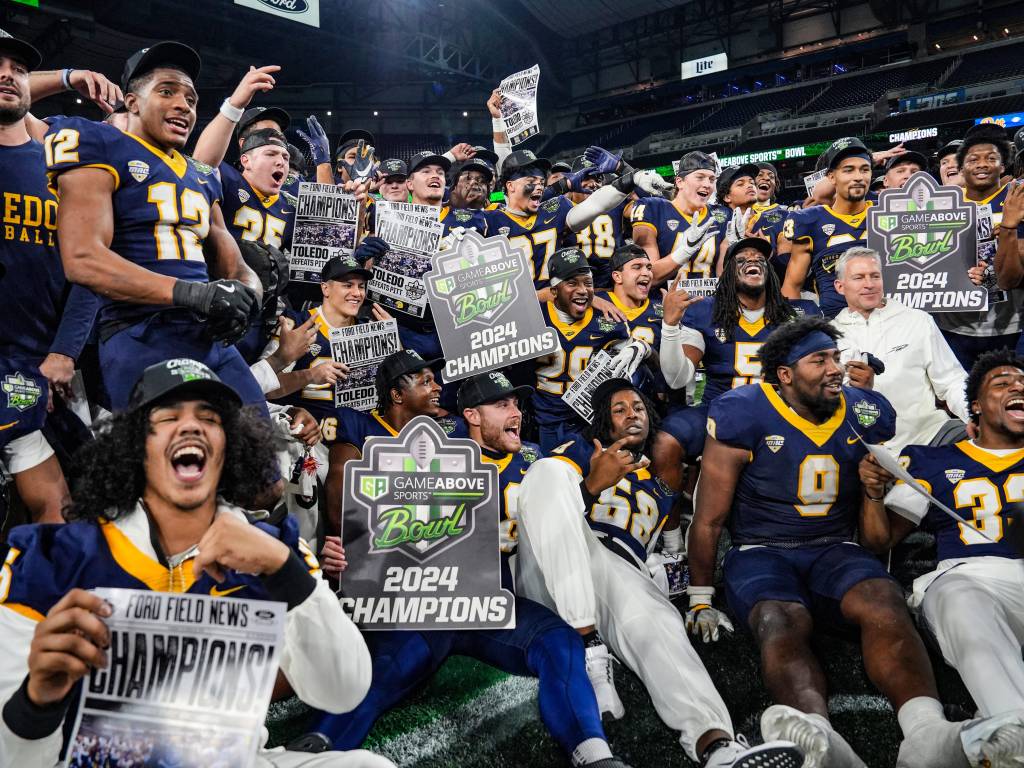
[782,137,871,317]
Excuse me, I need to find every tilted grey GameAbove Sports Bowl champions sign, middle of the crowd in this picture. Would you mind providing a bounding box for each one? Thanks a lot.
[423,229,559,381]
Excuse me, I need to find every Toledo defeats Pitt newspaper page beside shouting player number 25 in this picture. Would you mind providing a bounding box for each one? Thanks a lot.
[288,181,362,283]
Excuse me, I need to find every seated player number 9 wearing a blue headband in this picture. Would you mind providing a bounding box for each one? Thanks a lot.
[686,317,1024,768]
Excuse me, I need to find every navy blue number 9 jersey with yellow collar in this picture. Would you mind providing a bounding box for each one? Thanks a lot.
[708,383,896,544]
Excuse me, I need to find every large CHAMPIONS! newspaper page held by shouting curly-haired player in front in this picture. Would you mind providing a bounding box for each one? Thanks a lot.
[66,589,287,768]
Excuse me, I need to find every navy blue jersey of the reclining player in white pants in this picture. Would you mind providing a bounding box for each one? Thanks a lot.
[551,440,673,562]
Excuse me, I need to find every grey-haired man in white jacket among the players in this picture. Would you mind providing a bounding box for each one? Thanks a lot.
[831,247,968,452]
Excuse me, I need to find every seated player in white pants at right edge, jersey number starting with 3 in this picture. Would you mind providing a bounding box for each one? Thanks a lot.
[861,350,1024,737]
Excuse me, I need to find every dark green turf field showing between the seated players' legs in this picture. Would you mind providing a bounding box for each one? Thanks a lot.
[271,536,973,768]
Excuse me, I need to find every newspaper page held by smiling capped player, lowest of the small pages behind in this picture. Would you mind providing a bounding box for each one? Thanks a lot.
[331,319,400,411]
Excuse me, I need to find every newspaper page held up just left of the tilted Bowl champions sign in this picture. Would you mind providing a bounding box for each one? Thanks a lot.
[367,200,444,317]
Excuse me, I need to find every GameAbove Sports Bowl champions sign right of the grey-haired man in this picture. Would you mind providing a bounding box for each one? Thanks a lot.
[867,171,988,312]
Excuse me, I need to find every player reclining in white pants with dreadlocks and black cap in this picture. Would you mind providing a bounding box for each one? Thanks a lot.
[517,379,803,768]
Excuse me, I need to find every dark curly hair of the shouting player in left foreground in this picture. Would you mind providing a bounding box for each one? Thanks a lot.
[65,398,279,520]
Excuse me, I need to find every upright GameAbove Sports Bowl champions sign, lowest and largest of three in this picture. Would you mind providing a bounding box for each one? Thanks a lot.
[341,416,515,630]
